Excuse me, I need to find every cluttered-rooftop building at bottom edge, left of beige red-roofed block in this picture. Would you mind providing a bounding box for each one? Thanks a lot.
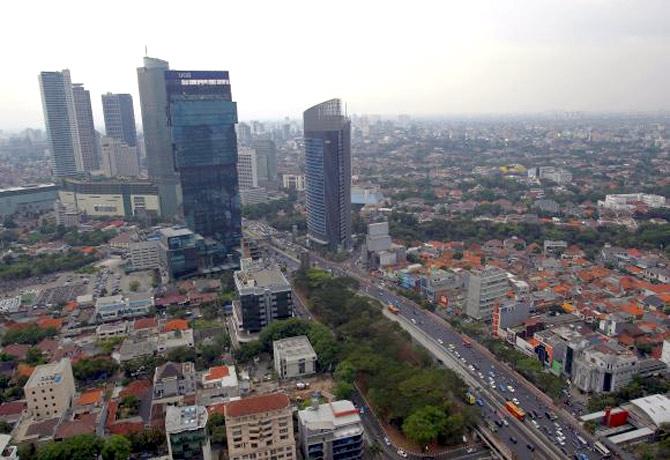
[165,406,212,460]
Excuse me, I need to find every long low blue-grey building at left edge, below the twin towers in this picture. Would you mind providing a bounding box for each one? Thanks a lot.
[0,184,58,217]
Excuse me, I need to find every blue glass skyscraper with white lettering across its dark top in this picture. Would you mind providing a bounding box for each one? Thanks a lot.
[165,71,242,253]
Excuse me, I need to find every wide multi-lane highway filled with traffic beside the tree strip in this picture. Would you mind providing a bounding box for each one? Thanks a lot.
[258,227,600,459]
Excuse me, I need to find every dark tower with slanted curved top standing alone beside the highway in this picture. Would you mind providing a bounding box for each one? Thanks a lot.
[303,99,351,249]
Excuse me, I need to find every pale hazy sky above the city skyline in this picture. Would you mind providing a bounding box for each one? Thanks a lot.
[0,0,670,129]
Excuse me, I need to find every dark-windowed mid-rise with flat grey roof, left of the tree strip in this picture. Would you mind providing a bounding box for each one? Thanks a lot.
[233,259,293,333]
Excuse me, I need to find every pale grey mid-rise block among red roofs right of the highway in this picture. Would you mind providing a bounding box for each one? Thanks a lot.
[465,266,509,321]
